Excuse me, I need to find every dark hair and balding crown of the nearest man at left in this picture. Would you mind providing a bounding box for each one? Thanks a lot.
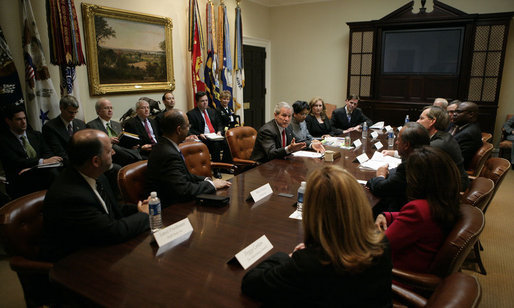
[67,129,103,167]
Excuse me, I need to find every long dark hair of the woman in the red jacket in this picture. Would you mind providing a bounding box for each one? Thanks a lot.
[406,146,460,232]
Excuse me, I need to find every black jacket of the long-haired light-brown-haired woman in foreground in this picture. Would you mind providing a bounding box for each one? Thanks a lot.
[242,237,392,307]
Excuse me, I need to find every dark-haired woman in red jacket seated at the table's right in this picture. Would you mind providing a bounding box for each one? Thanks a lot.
[375,146,460,273]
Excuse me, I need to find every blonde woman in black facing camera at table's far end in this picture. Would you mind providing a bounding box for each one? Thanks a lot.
[305,97,342,138]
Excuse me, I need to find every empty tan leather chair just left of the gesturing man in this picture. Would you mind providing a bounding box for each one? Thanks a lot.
[225,126,257,172]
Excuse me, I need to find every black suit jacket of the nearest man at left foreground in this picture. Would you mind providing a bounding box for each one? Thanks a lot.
[40,167,149,261]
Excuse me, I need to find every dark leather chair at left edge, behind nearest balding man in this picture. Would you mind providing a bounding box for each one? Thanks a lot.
[0,190,54,307]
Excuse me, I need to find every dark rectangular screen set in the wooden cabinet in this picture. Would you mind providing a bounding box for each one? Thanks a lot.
[382,27,464,75]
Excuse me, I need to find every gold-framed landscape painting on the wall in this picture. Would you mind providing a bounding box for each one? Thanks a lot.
[82,3,175,95]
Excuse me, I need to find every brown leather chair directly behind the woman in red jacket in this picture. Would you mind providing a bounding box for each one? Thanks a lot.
[393,204,485,295]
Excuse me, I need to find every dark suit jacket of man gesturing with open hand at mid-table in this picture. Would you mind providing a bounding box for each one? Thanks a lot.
[250,119,293,163]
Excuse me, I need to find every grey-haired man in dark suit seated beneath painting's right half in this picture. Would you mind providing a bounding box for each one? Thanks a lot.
[124,99,159,159]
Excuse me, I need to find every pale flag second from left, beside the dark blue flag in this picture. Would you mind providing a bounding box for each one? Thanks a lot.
[20,0,60,131]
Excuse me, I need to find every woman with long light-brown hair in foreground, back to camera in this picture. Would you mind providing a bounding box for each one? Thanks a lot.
[242,165,392,307]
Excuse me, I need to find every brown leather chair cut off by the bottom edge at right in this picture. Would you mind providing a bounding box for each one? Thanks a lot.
[393,272,482,308]
